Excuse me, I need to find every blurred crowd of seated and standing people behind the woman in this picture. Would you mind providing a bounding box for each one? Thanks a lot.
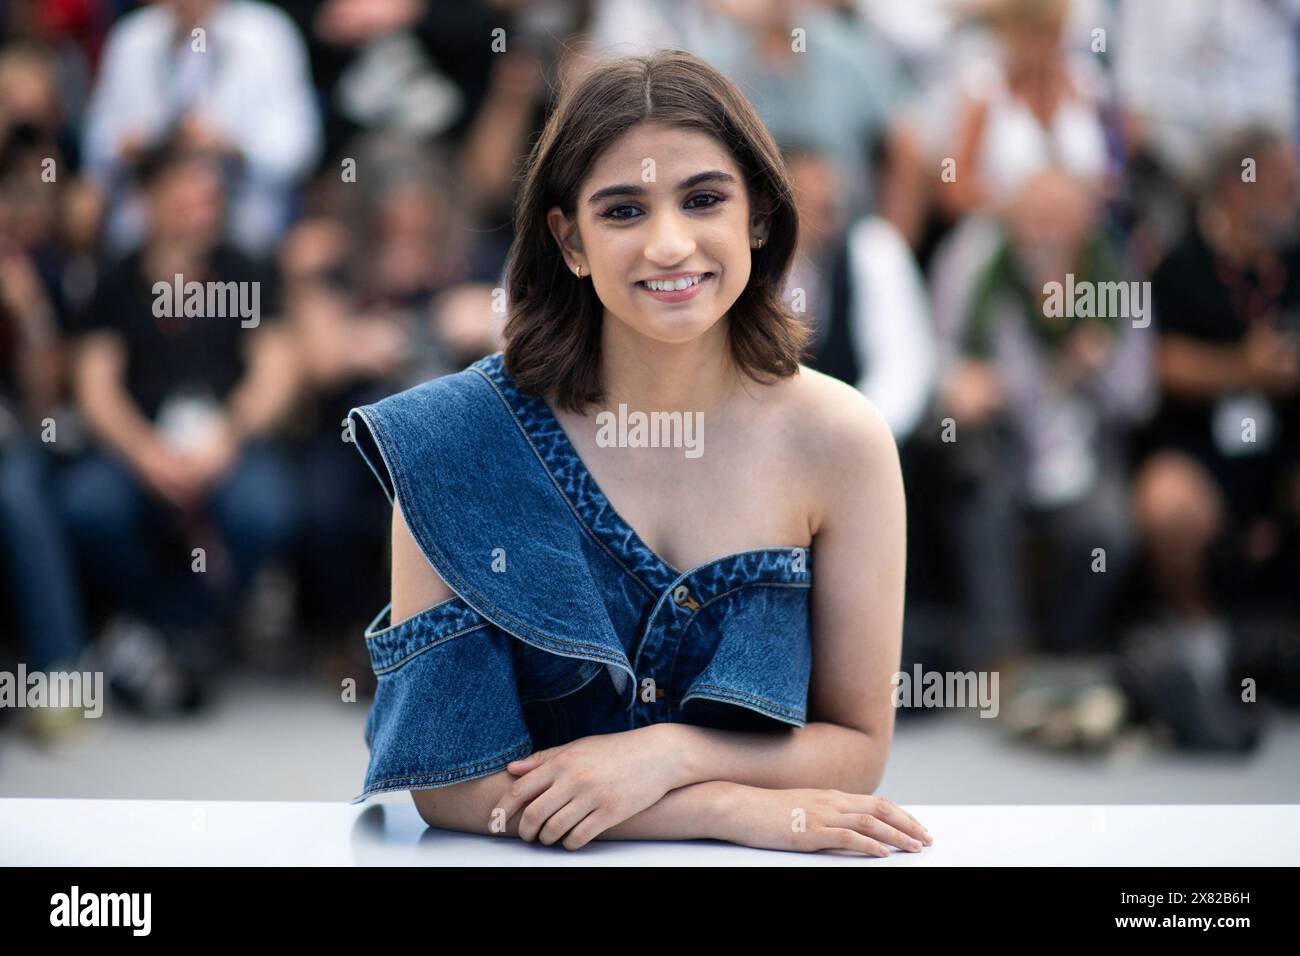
[0,0,1300,750]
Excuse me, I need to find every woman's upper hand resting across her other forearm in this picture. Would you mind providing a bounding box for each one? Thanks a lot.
[501,724,684,849]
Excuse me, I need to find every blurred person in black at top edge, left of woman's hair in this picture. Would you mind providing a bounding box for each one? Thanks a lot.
[285,0,559,282]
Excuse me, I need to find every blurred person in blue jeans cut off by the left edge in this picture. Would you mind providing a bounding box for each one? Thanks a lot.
[0,43,98,743]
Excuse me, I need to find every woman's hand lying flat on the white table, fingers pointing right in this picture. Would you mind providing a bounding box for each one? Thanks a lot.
[722,787,935,856]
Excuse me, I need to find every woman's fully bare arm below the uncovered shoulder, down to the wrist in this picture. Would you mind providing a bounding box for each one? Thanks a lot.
[647,372,907,793]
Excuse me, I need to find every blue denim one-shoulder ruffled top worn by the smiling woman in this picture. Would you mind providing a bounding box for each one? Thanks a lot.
[348,352,811,803]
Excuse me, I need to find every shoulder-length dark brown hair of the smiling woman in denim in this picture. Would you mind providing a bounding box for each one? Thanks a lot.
[504,49,809,412]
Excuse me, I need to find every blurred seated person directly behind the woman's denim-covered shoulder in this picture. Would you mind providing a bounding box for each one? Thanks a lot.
[281,134,503,685]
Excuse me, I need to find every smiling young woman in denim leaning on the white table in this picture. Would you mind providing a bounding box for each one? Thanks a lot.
[352,51,931,856]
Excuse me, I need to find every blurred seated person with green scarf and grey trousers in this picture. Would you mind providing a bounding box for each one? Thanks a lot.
[935,169,1154,702]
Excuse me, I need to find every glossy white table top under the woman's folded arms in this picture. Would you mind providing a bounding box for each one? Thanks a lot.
[0,793,1300,866]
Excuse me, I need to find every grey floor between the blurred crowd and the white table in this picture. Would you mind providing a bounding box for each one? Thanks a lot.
[0,676,1300,805]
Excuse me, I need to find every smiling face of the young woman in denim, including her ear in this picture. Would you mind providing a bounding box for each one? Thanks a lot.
[547,124,767,343]
